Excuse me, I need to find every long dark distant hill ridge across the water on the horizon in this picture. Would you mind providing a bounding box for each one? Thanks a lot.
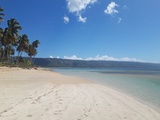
[34,58,160,69]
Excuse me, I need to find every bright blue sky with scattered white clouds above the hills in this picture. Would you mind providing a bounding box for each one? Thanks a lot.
[0,0,160,63]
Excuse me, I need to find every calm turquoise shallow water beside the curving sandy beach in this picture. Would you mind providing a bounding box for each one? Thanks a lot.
[54,68,160,112]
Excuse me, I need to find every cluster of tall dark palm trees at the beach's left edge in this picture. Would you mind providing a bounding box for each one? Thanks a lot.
[0,8,40,65]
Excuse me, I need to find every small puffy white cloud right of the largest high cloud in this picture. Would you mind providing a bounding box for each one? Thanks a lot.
[104,2,119,15]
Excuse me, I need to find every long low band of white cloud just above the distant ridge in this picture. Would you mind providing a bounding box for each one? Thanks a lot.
[63,55,143,62]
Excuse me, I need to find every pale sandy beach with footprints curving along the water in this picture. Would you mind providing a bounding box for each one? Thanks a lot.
[0,67,160,120]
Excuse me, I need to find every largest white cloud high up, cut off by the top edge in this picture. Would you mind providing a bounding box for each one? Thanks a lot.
[66,0,97,23]
